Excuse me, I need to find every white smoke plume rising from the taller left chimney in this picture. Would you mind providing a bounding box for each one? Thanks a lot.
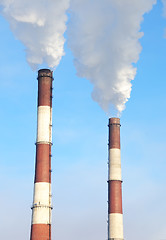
[0,0,69,70]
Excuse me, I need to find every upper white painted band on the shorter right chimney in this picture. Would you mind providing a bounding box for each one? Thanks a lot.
[109,148,122,181]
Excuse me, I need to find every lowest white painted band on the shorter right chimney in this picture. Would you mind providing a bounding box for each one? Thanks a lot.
[108,213,123,239]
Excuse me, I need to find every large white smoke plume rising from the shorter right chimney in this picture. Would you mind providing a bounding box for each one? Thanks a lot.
[68,0,156,113]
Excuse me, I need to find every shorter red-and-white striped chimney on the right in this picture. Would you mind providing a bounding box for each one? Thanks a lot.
[108,118,123,240]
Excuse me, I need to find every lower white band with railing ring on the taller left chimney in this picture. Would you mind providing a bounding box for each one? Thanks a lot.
[32,182,51,224]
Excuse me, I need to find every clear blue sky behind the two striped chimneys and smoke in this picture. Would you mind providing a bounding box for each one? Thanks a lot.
[0,1,166,240]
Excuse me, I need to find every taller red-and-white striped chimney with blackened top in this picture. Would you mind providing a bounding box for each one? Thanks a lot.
[30,69,53,240]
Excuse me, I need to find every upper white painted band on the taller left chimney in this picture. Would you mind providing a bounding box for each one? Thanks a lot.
[37,106,52,142]
